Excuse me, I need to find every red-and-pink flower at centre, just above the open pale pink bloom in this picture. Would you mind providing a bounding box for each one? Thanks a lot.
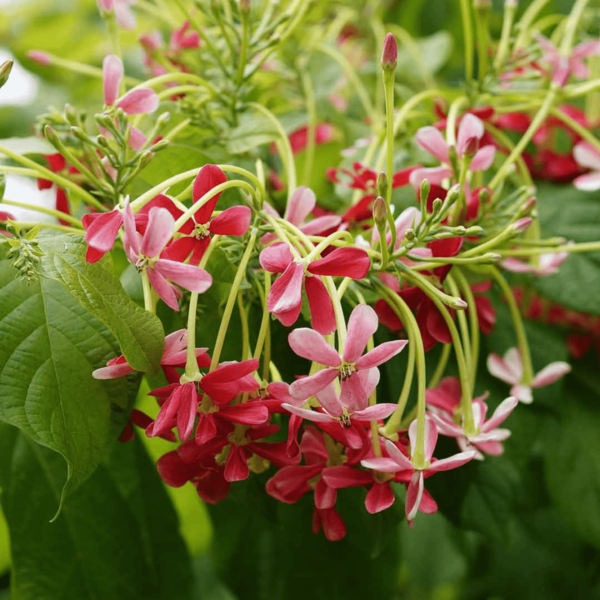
[259,242,371,335]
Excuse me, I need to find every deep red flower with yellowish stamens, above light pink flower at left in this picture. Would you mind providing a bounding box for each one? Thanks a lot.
[165,165,251,265]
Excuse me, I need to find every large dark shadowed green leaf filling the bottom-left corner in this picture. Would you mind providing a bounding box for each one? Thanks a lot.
[0,425,192,600]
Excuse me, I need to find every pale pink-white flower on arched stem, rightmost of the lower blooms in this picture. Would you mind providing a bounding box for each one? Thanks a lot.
[487,348,571,404]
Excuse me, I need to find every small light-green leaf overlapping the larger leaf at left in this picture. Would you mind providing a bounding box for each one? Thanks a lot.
[39,235,164,373]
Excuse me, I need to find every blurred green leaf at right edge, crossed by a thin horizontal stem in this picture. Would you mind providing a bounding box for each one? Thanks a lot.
[533,184,600,315]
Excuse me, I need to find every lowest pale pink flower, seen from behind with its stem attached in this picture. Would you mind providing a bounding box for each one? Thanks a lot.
[361,417,476,522]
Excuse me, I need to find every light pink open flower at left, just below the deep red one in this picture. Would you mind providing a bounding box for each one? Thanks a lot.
[123,202,212,311]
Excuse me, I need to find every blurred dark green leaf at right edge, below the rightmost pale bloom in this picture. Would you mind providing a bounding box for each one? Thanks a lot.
[545,376,600,548]
